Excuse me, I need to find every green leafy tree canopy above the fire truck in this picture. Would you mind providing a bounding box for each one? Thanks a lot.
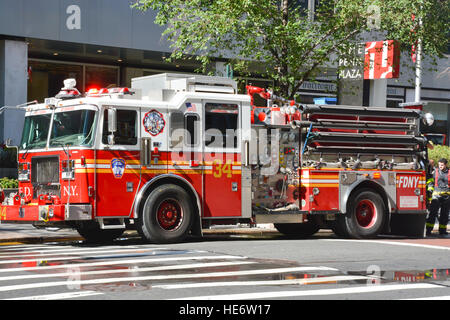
[133,0,450,99]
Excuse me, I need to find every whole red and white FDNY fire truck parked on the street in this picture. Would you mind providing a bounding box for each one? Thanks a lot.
[0,74,436,243]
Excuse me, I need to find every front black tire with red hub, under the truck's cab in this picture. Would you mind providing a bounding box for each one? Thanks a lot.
[137,184,194,243]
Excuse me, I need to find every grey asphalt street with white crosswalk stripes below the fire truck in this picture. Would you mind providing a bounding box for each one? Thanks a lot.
[0,228,450,308]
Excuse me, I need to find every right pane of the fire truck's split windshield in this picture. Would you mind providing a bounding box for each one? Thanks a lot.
[50,110,96,147]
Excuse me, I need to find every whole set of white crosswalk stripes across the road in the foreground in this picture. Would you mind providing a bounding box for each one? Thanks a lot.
[0,245,450,300]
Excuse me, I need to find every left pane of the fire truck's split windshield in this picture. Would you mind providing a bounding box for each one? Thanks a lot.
[20,113,52,149]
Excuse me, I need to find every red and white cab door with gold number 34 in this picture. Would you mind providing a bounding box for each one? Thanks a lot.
[202,100,242,218]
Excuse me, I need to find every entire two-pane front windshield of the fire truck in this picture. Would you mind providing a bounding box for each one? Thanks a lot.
[20,110,96,150]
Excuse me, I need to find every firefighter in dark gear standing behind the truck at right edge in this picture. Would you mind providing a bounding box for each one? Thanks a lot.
[426,158,450,236]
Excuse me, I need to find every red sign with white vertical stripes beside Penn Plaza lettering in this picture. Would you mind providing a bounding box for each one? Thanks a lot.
[364,40,400,79]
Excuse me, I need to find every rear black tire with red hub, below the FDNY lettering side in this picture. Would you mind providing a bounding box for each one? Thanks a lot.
[337,189,386,239]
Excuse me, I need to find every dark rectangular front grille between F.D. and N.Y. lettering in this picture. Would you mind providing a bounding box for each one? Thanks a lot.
[31,157,60,198]
